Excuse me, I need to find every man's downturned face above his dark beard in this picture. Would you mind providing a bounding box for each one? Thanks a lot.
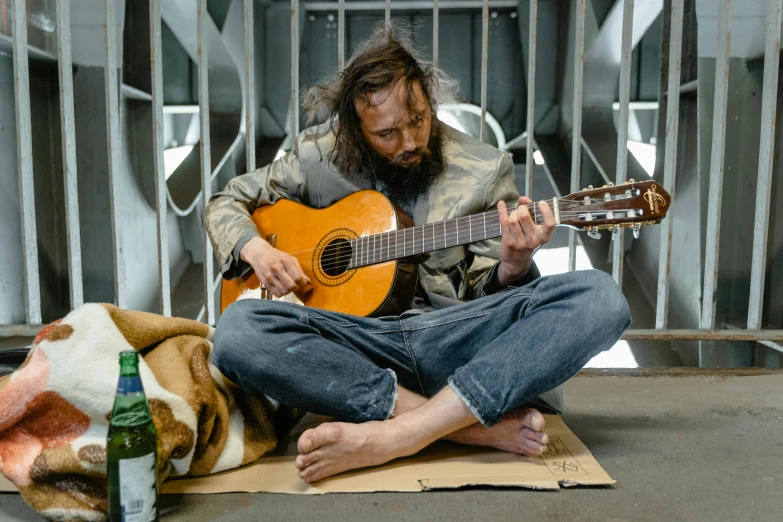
[356,81,432,168]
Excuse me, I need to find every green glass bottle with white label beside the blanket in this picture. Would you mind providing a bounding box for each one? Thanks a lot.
[106,350,158,522]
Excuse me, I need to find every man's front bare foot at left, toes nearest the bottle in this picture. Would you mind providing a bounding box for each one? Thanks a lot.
[296,421,422,484]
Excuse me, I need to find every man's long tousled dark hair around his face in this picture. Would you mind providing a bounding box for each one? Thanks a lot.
[302,23,458,178]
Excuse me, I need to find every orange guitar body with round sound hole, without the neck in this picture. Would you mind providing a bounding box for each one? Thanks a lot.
[220,190,418,317]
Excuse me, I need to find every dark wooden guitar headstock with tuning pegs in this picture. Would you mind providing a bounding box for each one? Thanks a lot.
[559,180,671,238]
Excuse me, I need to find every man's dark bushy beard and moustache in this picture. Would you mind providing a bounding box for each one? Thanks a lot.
[364,118,445,203]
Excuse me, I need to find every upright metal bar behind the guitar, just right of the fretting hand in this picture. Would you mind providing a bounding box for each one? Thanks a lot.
[568,0,585,271]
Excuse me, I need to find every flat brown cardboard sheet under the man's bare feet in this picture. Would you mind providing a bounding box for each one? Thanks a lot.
[0,415,615,495]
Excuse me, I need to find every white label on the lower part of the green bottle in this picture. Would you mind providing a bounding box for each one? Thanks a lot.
[119,453,157,522]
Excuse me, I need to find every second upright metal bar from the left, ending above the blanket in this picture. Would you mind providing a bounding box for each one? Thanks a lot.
[57,0,84,309]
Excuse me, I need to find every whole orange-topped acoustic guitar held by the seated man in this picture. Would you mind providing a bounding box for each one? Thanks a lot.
[221,180,671,316]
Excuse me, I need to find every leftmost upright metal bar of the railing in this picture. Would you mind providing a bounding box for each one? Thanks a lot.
[11,0,41,324]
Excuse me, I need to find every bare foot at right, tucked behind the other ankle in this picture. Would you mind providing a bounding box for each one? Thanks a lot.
[446,408,549,456]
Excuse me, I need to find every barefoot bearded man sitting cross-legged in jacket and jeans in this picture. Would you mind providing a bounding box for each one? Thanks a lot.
[205,23,630,483]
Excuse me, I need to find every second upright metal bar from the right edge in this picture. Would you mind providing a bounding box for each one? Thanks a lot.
[700,0,732,330]
